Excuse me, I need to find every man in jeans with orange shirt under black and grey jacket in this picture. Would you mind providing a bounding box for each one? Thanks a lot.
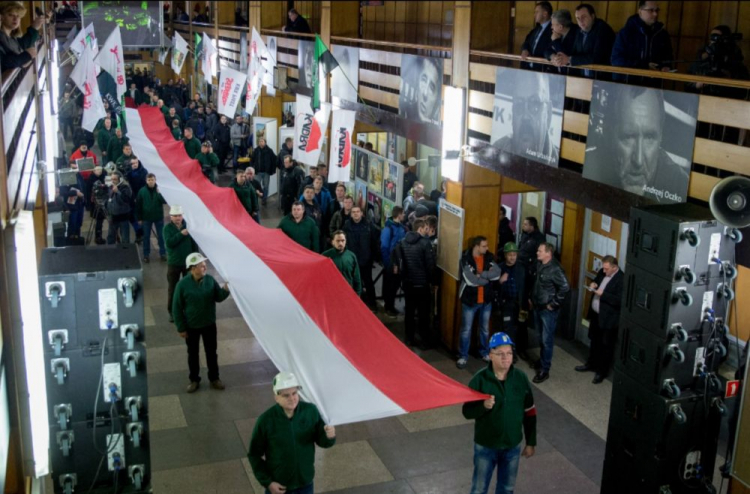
[456,235,501,369]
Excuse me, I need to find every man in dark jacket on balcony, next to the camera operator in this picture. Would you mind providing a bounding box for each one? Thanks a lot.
[612,2,674,72]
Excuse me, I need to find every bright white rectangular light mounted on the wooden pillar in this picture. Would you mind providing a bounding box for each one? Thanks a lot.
[440,86,466,182]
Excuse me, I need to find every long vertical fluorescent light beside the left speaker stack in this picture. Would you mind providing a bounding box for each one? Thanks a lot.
[15,211,49,478]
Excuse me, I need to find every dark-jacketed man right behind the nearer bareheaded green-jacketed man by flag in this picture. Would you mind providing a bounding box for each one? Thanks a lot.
[346,206,380,311]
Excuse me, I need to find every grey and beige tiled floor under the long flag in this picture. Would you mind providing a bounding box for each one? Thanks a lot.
[69,177,728,494]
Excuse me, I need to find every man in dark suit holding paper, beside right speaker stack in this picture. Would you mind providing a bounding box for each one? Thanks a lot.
[576,256,625,384]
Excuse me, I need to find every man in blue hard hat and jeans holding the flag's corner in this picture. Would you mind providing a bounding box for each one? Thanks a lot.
[463,333,536,494]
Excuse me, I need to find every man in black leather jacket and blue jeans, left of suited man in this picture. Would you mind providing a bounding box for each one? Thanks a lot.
[531,243,570,384]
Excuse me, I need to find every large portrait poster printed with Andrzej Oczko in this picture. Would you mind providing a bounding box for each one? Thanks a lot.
[583,81,698,203]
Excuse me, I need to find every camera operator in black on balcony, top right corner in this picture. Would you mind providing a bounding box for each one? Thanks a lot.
[687,25,750,99]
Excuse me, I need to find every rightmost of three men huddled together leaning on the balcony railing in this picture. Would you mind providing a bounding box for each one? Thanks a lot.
[552,3,615,76]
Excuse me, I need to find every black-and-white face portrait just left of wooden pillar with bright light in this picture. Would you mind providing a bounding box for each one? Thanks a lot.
[398,55,443,125]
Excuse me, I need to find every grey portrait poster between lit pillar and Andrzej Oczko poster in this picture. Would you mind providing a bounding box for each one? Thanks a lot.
[491,67,565,167]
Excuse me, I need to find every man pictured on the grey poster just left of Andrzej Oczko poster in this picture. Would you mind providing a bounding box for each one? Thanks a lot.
[488,70,560,166]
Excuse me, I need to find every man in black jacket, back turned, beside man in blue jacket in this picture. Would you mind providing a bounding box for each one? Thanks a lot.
[392,218,435,348]
